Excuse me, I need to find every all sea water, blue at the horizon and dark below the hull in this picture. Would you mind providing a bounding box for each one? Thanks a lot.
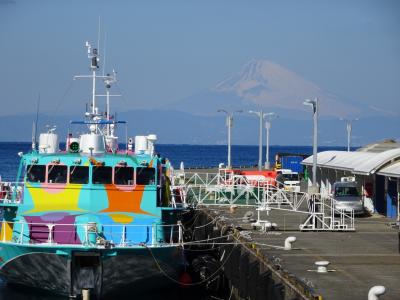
[0,142,345,300]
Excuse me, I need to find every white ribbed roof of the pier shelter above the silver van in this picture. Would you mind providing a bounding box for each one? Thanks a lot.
[302,148,400,175]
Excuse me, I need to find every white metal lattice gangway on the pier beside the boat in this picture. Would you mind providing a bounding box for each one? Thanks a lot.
[171,170,355,231]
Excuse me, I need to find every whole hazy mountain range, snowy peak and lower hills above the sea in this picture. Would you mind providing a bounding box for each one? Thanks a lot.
[0,60,400,146]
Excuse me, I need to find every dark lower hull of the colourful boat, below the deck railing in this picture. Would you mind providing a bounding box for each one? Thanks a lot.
[0,244,185,298]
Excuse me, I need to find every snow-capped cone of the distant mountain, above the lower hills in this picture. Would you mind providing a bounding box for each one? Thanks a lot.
[169,59,383,119]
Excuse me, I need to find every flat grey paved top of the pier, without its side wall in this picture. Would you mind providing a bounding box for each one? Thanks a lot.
[206,207,400,300]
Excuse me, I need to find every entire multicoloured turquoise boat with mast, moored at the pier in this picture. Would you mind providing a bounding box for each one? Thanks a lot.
[0,43,186,298]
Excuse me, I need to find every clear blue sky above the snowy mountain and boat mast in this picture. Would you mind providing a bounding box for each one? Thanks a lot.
[0,0,400,115]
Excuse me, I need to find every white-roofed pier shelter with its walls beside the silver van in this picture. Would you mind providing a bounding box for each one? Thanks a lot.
[302,148,400,217]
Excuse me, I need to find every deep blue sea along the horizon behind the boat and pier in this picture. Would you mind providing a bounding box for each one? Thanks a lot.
[0,142,346,181]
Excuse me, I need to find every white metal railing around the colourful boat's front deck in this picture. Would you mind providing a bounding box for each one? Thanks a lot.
[1,220,183,248]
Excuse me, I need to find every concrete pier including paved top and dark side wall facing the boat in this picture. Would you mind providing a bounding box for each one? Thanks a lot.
[191,206,400,300]
